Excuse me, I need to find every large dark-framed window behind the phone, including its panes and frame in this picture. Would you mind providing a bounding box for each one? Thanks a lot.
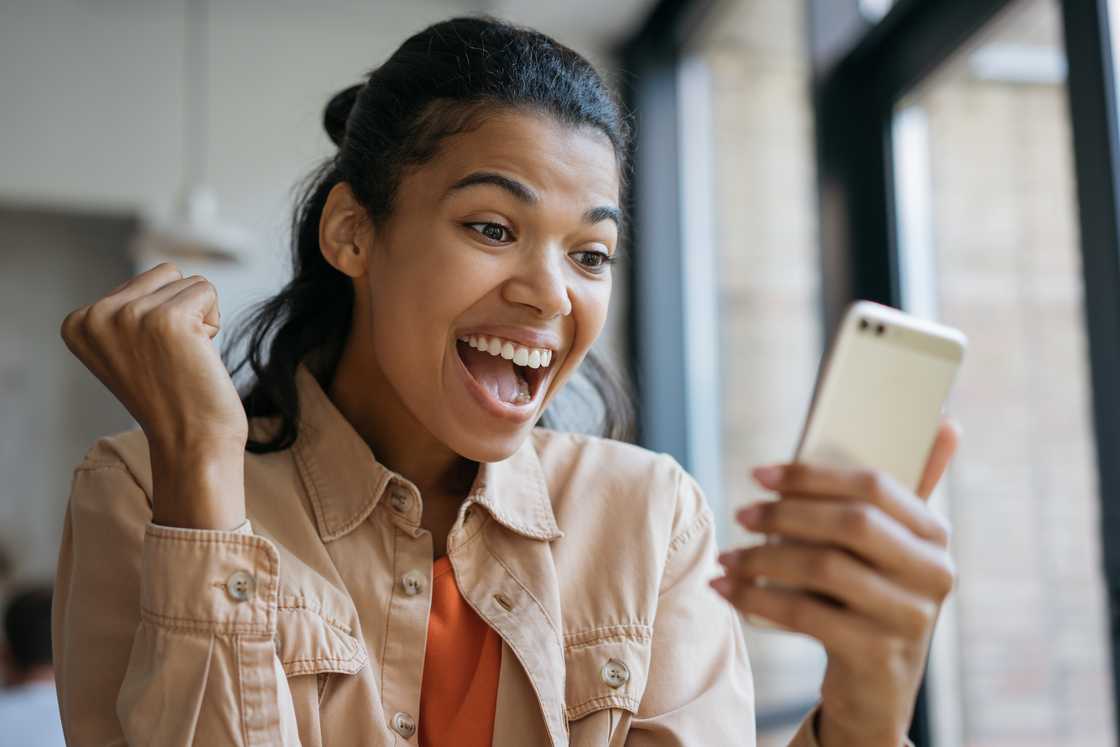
[627,0,1120,747]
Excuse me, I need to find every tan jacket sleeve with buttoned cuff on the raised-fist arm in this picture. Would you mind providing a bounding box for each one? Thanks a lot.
[53,452,299,747]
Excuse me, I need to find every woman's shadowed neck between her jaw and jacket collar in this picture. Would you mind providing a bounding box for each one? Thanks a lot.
[327,335,478,499]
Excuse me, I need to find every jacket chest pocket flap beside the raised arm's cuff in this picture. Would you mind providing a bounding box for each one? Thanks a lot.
[276,606,367,676]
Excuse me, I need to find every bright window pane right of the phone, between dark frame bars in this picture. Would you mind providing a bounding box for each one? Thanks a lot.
[893,0,1114,747]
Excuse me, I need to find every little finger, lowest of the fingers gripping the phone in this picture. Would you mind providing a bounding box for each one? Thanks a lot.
[710,577,880,653]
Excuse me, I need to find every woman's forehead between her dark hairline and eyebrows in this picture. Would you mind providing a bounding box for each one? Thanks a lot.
[421,111,619,206]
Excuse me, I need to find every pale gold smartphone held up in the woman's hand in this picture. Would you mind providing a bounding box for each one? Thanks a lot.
[747,301,968,627]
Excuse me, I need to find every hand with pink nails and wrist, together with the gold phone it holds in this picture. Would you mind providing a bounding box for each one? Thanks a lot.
[711,302,964,744]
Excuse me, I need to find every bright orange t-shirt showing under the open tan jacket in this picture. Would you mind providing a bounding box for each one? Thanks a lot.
[419,555,502,747]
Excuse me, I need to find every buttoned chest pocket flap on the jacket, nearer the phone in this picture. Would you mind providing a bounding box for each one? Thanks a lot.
[564,625,651,720]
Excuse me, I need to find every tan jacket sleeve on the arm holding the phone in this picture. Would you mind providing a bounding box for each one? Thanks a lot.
[626,467,819,747]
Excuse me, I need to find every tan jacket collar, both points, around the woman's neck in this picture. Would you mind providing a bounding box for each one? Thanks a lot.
[284,363,563,542]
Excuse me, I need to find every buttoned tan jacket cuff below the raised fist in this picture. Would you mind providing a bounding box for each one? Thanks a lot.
[140,522,280,637]
